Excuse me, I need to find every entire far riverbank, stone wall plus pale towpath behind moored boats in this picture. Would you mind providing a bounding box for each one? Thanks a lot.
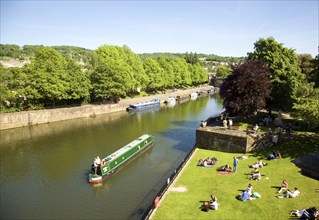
[0,85,212,130]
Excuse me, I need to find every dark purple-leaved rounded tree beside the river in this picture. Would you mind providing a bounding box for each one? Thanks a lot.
[219,60,270,116]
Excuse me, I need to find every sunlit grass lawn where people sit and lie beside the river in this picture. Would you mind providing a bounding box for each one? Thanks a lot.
[152,132,319,219]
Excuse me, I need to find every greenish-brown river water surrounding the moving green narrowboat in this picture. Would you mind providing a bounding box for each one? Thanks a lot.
[0,95,222,219]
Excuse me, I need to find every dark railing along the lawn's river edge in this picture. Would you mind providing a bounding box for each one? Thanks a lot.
[140,146,196,220]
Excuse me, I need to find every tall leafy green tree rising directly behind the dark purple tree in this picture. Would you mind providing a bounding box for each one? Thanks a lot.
[248,37,305,110]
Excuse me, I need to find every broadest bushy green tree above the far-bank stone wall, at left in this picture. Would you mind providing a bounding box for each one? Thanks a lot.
[22,47,90,107]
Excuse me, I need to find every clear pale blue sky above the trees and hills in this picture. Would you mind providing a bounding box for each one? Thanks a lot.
[1,0,319,57]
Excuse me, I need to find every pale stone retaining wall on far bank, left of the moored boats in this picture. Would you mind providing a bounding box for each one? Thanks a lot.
[0,104,126,130]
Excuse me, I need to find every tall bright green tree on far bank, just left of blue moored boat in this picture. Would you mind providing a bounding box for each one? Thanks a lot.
[91,45,136,101]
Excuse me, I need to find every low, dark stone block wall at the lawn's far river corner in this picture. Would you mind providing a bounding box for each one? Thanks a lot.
[196,127,255,153]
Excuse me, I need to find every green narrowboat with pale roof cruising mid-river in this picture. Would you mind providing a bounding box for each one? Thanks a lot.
[89,134,154,183]
